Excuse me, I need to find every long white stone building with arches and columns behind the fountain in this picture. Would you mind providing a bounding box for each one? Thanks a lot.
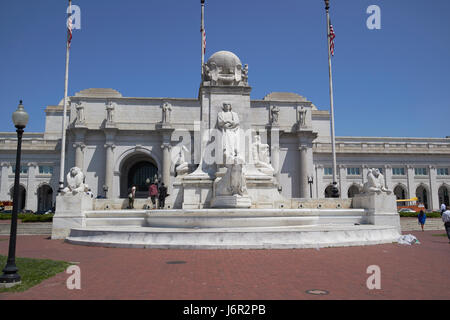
[0,51,450,211]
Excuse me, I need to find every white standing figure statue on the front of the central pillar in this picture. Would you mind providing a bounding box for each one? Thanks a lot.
[217,103,240,164]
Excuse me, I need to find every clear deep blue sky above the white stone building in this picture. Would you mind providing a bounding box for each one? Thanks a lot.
[0,0,450,137]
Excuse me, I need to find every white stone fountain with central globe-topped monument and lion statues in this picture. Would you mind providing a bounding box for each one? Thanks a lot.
[52,51,401,249]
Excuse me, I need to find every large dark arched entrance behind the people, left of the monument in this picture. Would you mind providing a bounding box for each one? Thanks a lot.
[120,153,159,198]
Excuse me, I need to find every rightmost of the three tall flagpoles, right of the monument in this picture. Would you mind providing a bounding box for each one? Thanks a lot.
[325,0,339,198]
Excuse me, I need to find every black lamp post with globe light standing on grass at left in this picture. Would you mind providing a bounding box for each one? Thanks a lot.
[0,101,29,287]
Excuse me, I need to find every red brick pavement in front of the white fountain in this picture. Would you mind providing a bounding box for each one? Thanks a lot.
[0,231,450,300]
